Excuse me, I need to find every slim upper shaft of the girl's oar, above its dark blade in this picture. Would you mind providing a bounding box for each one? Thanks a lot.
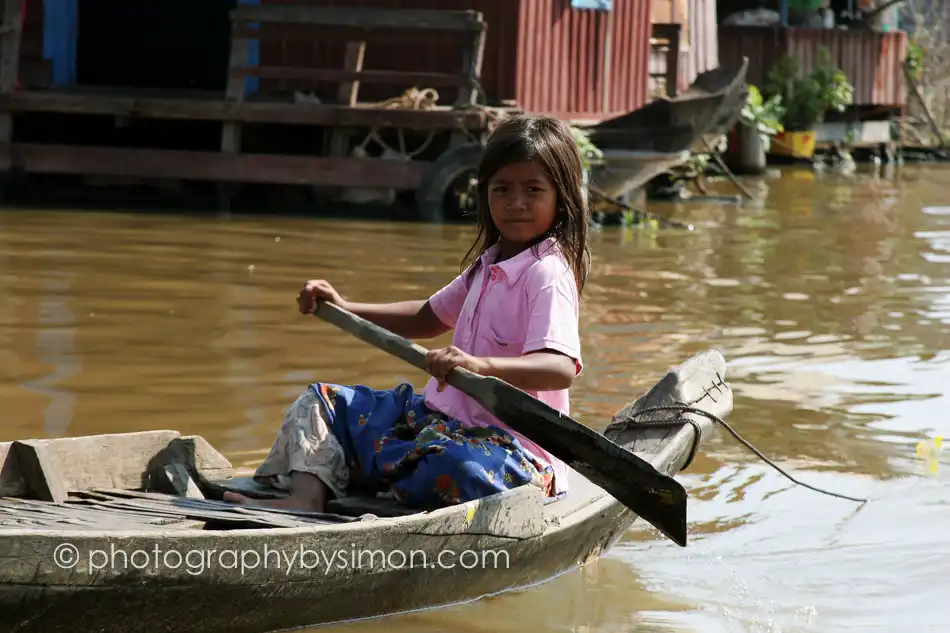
[314,299,484,397]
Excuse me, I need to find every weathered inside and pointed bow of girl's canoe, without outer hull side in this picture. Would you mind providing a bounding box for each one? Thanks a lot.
[0,351,732,537]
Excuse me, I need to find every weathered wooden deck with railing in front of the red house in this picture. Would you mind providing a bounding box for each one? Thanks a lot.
[0,0,491,207]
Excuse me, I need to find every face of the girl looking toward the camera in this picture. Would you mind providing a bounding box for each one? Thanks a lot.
[488,161,557,247]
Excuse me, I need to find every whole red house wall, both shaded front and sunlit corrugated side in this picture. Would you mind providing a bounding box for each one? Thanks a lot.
[261,0,652,119]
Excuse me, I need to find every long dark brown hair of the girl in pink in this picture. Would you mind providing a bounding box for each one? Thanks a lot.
[462,115,590,295]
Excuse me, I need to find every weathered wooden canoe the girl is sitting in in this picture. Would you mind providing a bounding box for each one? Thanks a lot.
[0,351,732,633]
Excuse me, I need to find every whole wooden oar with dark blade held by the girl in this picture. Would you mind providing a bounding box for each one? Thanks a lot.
[314,300,686,546]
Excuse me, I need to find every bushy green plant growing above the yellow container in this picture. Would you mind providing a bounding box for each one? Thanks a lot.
[764,46,854,130]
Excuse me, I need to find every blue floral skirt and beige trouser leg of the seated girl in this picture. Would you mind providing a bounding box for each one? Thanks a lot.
[256,383,554,509]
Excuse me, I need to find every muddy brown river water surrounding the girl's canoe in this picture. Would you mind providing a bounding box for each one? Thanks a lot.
[0,167,950,633]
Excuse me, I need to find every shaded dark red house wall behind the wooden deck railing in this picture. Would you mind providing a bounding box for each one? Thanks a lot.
[261,0,518,105]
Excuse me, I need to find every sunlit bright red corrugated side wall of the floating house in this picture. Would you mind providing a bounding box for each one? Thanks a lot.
[516,0,651,120]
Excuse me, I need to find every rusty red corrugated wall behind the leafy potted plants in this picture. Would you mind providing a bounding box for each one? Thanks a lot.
[719,26,907,107]
